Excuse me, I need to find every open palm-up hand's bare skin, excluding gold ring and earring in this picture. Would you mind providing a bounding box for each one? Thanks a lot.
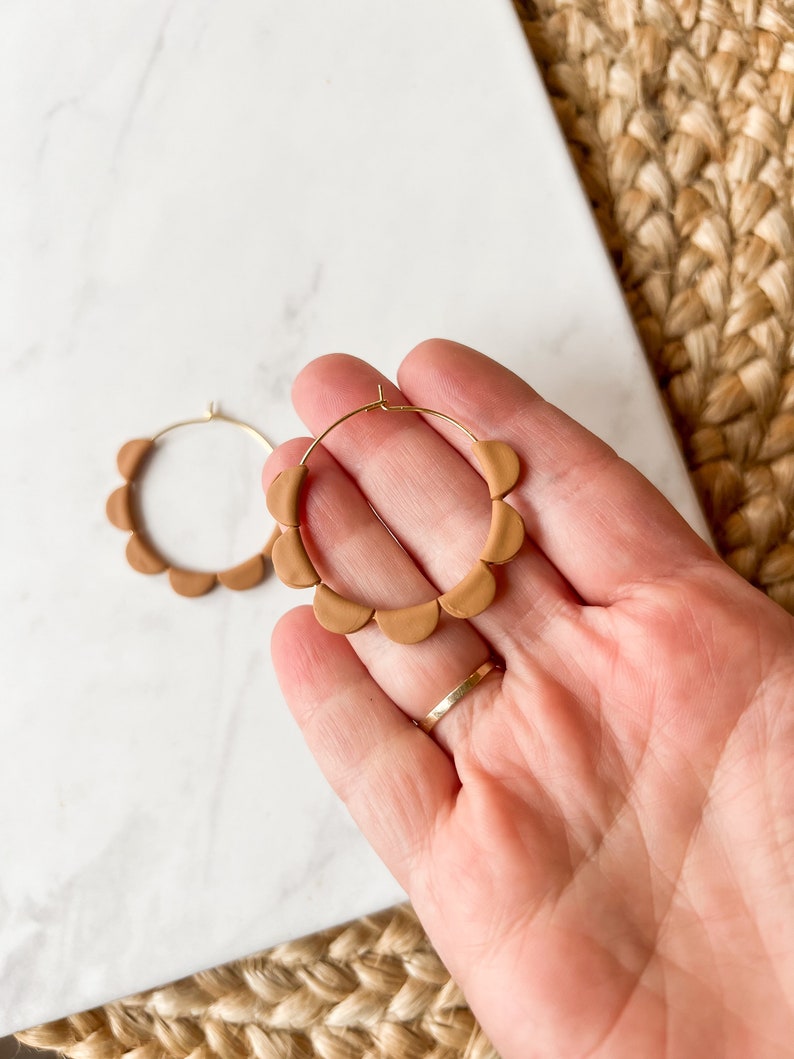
[265,340,794,1059]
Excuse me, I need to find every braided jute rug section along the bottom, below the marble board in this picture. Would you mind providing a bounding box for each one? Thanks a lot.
[17,905,494,1059]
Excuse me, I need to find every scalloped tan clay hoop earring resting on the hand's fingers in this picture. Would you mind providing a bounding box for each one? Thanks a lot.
[267,387,525,644]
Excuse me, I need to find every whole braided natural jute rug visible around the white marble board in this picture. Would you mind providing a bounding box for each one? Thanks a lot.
[18,0,794,1059]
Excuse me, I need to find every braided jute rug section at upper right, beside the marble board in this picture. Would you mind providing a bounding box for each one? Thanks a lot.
[517,0,794,611]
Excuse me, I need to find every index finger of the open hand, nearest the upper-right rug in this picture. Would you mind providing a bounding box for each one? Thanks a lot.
[398,339,718,605]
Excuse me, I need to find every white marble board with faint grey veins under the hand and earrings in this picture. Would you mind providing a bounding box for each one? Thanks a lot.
[0,0,703,1034]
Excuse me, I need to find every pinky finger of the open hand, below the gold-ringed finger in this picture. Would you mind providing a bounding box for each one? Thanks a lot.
[272,607,459,891]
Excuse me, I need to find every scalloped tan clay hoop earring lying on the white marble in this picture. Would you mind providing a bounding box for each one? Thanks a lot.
[106,405,281,596]
